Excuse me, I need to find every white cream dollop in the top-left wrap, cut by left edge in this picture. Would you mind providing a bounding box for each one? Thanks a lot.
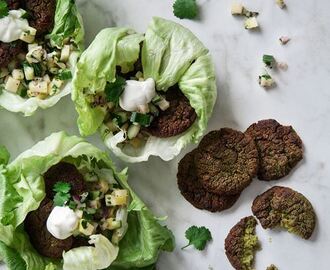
[0,9,29,43]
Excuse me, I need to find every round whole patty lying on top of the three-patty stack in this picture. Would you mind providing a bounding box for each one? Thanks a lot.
[195,128,258,195]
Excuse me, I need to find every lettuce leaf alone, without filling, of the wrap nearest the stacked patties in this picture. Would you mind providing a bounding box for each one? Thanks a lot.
[72,17,217,162]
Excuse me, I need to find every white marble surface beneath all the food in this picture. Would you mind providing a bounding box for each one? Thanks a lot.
[0,0,330,270]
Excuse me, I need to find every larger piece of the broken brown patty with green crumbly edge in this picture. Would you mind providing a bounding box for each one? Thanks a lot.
[252,186,316,239]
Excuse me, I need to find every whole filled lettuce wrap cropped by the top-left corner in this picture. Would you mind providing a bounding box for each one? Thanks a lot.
[0,0,84,116]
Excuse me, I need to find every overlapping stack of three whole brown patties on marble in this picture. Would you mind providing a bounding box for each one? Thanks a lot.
[177,119,303,212]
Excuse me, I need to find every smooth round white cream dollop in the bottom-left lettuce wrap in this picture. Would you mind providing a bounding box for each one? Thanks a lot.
[46,206,79,240]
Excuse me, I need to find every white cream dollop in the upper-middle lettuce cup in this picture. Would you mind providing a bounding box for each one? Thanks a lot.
[119,78,156,112]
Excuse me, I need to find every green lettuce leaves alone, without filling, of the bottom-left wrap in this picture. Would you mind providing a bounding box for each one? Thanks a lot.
[0,132,174,270]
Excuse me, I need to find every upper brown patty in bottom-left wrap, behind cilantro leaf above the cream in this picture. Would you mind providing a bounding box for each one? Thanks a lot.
[44,162,86,199]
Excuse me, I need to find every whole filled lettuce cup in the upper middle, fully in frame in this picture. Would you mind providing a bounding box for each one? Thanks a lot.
[72,17,217,165]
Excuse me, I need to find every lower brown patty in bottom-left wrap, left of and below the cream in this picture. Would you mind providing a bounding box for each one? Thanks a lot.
[24,198,73,259]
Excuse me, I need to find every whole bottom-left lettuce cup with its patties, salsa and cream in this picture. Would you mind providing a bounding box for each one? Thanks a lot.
[0,132,174,270]
